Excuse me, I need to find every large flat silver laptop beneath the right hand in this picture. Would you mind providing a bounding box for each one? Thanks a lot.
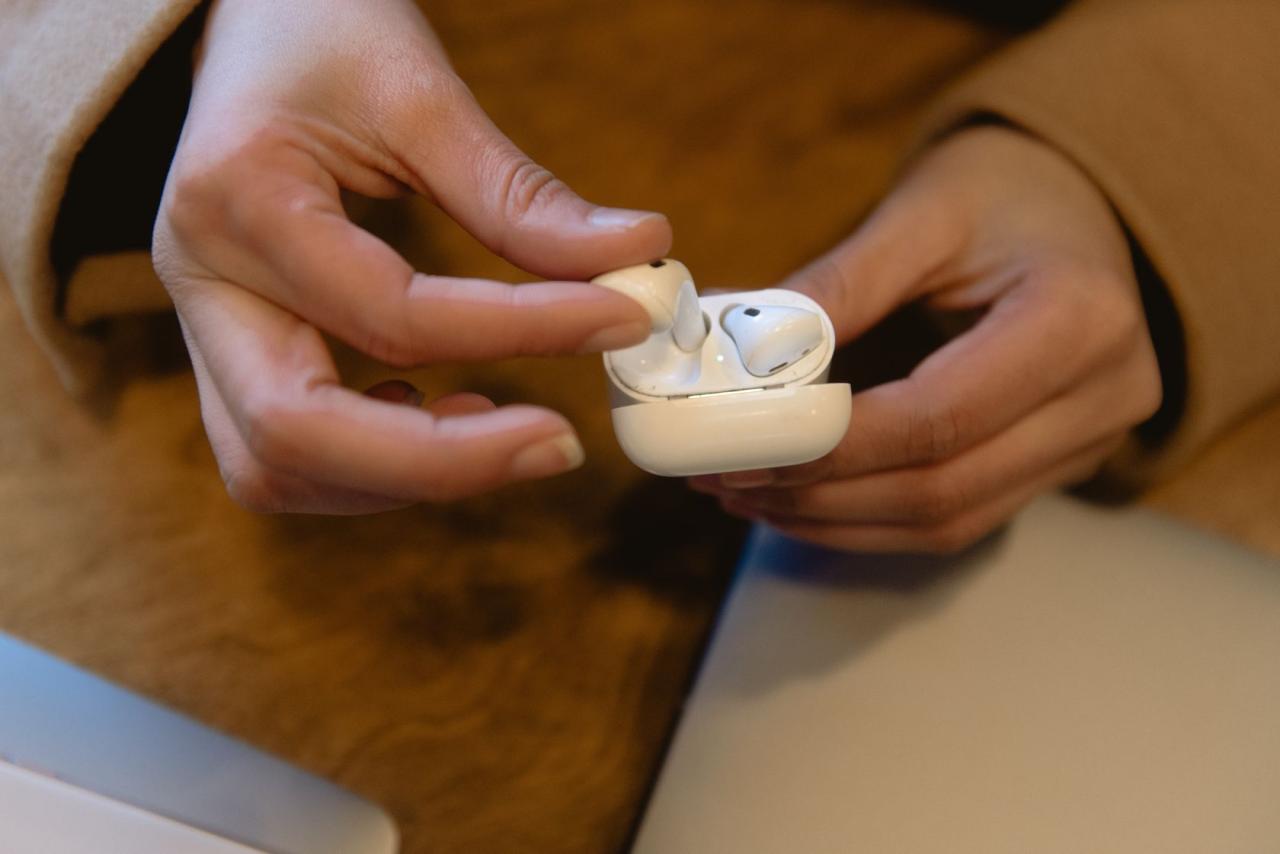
[634,497,1280,854]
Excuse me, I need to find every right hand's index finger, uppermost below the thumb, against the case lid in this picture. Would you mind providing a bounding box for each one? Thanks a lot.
[742,270,1131,485]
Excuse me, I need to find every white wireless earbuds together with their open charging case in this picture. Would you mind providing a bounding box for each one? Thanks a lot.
[593,259,851,476]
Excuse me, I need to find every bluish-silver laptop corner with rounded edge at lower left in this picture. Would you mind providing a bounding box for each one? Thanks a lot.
[0,635,398,854]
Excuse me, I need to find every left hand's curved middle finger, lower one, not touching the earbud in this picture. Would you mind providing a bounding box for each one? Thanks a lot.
[174,283,581,501]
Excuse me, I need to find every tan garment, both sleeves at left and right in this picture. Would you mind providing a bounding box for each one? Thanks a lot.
[0,0,1280,479]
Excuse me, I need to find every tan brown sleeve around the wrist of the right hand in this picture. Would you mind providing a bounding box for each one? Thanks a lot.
[925,0,1280,484]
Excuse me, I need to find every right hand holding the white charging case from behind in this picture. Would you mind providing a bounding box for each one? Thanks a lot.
[692,127,1161,552]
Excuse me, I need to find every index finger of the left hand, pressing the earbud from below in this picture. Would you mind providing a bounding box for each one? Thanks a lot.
[168,149,649,366]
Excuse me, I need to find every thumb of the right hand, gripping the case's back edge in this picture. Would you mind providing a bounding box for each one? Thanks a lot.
[781,187,960,344]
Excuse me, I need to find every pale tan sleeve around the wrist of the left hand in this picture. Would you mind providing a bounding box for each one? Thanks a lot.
[0,0,198,389]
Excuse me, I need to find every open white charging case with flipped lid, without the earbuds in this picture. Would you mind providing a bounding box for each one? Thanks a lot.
[604,289,851,478]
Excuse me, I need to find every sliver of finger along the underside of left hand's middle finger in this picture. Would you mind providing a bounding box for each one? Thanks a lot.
[179,316,411,516]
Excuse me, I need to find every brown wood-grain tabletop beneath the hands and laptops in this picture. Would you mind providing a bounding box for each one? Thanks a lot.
[0,0,1280,854]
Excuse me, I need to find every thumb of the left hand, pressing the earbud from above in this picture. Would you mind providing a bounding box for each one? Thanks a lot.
[397,75,671,279]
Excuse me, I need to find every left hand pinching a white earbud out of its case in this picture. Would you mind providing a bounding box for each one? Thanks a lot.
[154,0,671,512]
